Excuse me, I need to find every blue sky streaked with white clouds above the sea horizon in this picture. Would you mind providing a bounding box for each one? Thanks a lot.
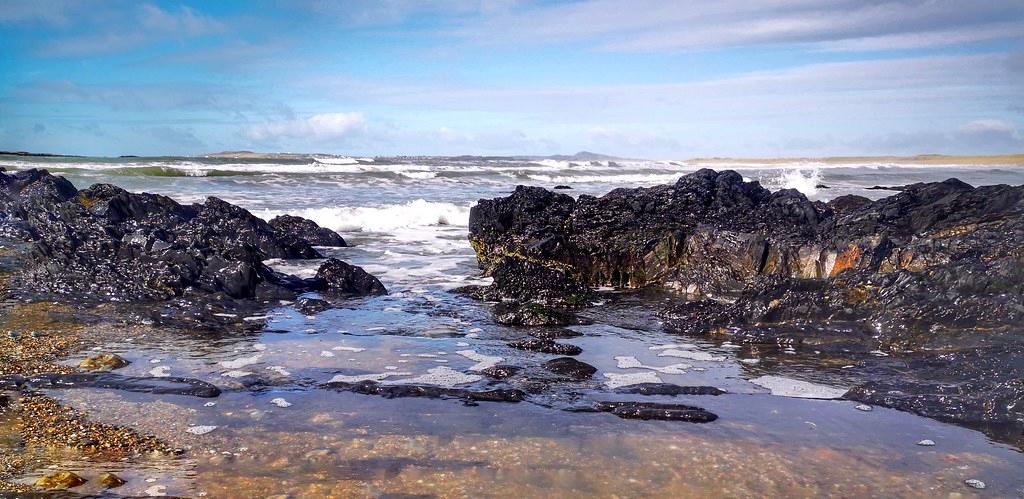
[0,0,1024,159]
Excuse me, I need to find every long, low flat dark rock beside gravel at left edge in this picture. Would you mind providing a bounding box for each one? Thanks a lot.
[0,373,220,399]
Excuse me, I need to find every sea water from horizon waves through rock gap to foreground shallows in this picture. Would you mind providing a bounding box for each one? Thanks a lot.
[0,155,1024,497]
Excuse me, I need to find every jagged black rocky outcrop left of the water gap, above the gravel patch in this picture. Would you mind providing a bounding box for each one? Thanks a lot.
[0,170,386,309]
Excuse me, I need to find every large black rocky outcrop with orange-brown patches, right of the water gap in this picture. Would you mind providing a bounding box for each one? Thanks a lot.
[469,170,1024,443]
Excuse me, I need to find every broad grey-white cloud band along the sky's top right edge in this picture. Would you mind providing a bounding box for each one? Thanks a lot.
[455,0,1024,51]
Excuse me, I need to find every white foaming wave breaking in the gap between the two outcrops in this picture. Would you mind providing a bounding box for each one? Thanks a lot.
[255,199,471,233]
